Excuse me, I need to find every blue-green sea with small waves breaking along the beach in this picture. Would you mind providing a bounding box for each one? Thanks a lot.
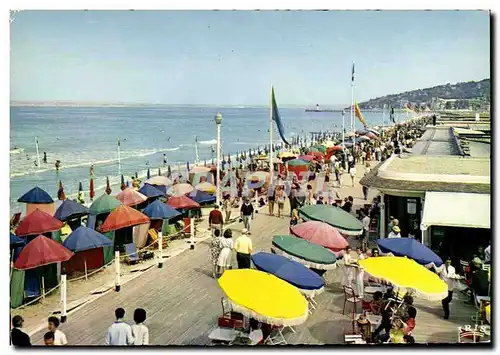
[10,106,398,214]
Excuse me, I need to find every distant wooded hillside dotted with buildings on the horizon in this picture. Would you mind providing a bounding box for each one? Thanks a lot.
[359,79,491,109]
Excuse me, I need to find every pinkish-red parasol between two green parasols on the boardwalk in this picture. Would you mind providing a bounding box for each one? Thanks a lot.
[290,221,349,252]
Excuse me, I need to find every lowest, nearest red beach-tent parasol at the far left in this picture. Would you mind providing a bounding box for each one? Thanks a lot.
[14,235,74,270]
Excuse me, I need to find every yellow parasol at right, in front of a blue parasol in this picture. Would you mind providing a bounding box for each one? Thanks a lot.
[358,256,448,301]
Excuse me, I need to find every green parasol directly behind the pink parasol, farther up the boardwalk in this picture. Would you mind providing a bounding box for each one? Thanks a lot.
[299,205,363,235]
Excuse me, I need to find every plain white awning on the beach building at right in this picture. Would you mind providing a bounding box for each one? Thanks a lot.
[420,192,491,230]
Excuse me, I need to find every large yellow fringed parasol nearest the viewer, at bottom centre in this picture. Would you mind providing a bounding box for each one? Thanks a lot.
[218,269,308,326]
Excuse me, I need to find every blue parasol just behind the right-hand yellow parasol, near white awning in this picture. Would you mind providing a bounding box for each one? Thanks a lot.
[377,238,443,266]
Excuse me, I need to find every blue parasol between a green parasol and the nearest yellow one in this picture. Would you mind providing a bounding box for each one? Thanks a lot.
[252,252,325,297]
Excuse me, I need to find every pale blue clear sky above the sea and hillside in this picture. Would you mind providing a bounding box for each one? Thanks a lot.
[10,11,490,106]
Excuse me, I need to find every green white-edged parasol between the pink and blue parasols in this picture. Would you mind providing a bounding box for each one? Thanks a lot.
[271,235,337,270]
